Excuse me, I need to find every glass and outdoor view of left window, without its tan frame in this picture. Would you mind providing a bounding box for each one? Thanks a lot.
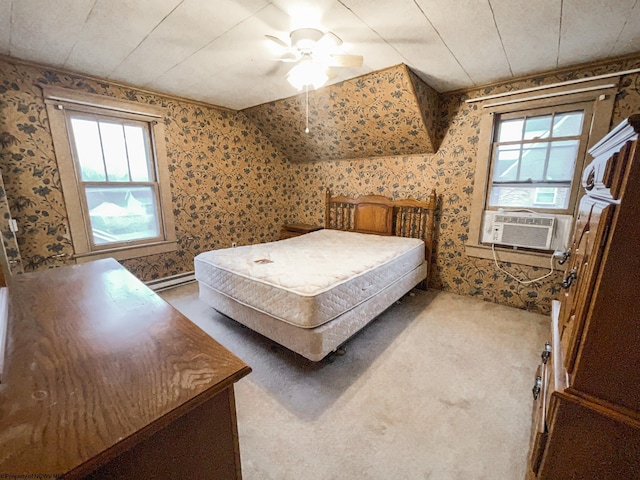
[69,113,162,247]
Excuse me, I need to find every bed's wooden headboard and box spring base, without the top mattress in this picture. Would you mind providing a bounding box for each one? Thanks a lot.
[200,190,436,361]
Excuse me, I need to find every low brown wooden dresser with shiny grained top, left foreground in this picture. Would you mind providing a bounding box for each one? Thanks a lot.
[0,259,251,480]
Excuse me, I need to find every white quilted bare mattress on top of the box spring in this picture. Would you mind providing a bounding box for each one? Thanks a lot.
[194,230,425,328]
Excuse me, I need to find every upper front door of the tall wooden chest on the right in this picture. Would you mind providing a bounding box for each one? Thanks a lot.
[559,196,614,374]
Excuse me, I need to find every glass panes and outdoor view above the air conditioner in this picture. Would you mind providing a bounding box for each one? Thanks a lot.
[488,110,584,210]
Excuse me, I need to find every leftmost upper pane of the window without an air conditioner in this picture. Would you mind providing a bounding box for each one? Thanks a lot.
[71,117,106,182]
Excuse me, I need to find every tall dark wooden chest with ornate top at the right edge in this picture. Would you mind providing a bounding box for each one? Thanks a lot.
[528,115,640,480]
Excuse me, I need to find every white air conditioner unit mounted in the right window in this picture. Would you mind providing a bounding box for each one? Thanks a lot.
[489,213,556,250]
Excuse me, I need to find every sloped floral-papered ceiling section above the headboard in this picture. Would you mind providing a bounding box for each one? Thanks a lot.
[243,65,438,162]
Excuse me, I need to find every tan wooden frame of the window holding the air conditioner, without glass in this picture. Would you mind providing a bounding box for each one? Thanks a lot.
[465,77,619,268]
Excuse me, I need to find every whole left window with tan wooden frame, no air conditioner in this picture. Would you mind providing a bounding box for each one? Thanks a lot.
[45,88,176,259]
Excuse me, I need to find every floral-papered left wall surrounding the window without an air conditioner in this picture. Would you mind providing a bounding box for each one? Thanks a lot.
[0,59,288,281]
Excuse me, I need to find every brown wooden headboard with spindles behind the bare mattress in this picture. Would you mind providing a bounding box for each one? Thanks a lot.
[324,189,437,262]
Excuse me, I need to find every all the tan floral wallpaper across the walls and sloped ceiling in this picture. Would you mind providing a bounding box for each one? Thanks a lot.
[0,52,640,313]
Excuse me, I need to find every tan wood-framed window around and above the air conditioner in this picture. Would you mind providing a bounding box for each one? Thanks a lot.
[465,78,618,267]
